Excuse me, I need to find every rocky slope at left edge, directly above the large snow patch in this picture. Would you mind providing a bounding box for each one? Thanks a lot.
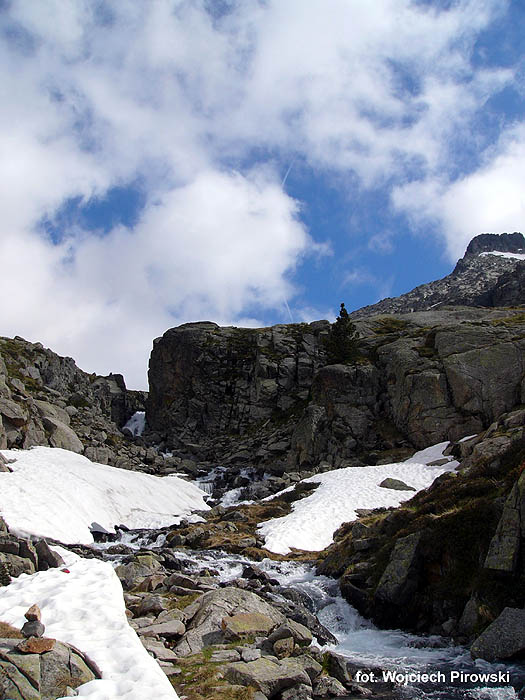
[0,337,154,468]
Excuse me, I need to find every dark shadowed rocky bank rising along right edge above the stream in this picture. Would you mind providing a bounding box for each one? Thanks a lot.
[318,408,525,636]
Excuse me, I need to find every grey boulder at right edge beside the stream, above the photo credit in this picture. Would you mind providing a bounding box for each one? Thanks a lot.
[470,608,525,661]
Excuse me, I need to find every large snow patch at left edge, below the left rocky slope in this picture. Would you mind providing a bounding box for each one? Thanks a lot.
[0,447,209,544]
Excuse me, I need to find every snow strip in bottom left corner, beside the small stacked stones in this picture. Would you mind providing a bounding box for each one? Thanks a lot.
[0,548,178,700]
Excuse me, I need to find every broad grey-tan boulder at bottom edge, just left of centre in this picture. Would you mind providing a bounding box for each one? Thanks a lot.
[224,657,311,698]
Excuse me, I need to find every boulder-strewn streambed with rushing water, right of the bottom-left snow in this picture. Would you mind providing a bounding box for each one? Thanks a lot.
[91,531,525,700]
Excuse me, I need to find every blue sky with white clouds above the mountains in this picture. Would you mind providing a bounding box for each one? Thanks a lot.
[0,0,525,389]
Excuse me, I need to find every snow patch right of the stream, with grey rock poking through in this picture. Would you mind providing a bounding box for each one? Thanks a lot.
[258,442,458,554]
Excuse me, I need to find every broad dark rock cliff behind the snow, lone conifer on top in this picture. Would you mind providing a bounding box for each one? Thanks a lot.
[147,307,525,473]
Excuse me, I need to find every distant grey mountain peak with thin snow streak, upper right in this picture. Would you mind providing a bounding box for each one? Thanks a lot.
[351,233,525,318]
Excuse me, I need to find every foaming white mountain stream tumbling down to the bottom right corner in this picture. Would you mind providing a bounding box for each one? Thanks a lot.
[99,533,525,700]
